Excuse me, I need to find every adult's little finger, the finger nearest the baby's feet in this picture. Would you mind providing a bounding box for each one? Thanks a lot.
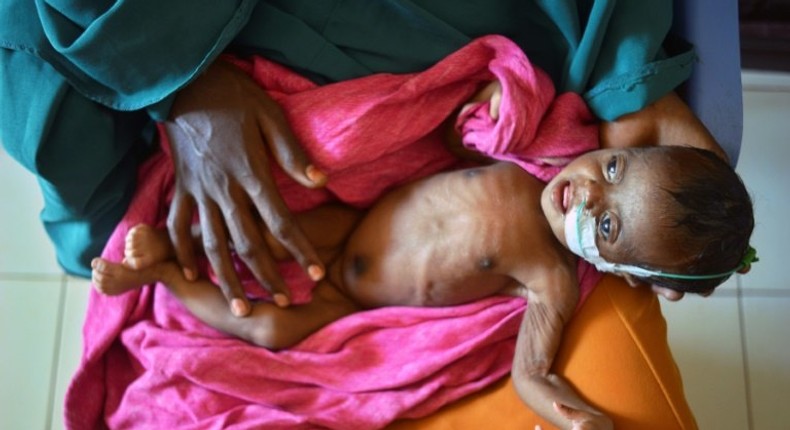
[167,192,197,281]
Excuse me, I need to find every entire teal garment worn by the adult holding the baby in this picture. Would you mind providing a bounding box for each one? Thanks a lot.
[0,0,694,275]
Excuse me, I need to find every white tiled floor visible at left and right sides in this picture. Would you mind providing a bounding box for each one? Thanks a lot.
[0,74,790,430]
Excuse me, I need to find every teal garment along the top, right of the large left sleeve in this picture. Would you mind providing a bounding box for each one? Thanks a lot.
[240,0,695,120]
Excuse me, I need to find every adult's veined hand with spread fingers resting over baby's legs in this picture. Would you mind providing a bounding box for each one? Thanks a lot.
[164,61,326,316]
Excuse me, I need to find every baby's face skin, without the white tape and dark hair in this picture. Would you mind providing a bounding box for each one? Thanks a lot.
[541,149,674,267]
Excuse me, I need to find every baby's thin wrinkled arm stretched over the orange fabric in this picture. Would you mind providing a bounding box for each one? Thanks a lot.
[512,265,612,429]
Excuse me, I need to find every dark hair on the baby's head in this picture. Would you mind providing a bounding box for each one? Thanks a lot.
[643,146,754,294]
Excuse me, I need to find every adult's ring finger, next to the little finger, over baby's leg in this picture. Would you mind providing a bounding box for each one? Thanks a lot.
[199,202,252,317]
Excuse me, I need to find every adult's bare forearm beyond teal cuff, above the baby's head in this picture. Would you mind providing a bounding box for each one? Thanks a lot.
[599,91,729,161]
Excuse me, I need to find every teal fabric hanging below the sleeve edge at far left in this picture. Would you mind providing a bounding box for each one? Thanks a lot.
[0,50,149,276]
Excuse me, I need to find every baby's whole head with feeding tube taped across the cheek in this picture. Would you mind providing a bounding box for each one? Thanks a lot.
[541,147,754,294]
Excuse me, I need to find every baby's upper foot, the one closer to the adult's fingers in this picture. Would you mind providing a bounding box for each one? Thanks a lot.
[123,224,174,270]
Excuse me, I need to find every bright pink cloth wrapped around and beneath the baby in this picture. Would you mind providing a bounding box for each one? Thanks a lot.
[65,36,599,429]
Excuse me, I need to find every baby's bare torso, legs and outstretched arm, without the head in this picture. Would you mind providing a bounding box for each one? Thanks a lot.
[93,159,597,423]
